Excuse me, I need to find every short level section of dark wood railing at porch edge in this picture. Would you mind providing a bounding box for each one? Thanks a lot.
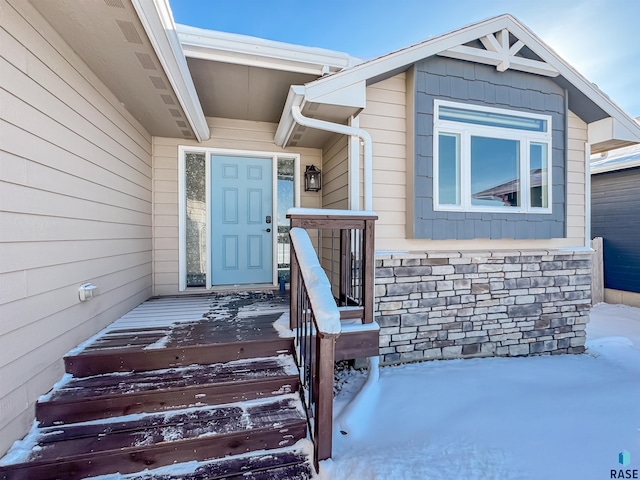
[287,208,378,328]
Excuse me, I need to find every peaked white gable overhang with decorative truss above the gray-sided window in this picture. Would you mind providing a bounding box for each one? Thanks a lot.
[276,15,640,152]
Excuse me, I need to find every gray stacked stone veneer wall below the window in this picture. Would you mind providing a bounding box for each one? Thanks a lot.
[375,251,591,364]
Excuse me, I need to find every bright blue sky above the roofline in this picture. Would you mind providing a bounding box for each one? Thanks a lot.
[170,0,640,117]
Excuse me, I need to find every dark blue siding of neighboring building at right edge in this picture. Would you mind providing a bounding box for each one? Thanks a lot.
[591,168,640,293]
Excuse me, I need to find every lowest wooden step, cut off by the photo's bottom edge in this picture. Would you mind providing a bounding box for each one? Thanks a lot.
[121,440,314,480]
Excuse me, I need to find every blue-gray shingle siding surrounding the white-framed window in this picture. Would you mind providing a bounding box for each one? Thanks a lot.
[414,57,567,240]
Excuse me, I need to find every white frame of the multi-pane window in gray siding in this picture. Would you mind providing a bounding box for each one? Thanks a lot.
[433,99,553,214]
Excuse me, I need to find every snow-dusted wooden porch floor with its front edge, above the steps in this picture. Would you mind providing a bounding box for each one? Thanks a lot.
[65,292,292,377]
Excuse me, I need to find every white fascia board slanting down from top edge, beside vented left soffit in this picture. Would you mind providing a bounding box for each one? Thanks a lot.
[132,0,211,142]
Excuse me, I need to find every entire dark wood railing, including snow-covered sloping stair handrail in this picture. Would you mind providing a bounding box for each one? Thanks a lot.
[287,208,378,470]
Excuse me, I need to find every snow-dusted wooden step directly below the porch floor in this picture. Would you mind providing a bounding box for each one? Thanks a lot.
[36,355,299,426]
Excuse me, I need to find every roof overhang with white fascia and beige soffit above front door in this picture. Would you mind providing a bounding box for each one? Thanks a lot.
[177,25,359,125]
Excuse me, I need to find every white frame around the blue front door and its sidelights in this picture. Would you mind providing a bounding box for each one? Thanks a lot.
[178,145,300,292]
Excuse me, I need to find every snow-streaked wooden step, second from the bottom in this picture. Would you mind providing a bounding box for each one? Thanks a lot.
[0,394,307,480]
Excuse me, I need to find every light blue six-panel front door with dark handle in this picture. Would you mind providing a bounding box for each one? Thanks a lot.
[211,155,273,285]
